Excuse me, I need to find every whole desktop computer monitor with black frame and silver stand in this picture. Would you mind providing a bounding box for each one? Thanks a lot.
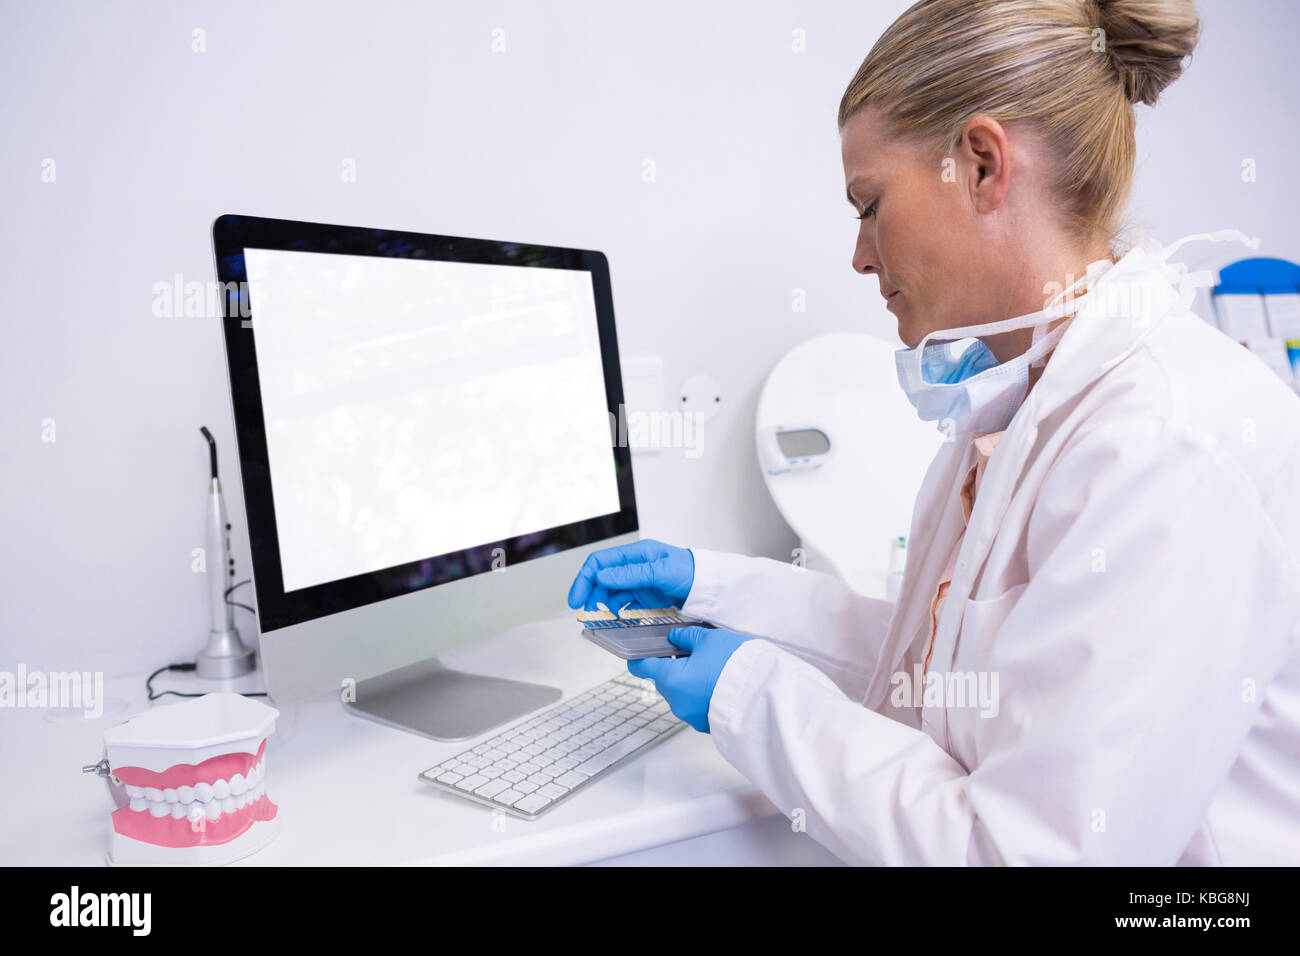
[212,216,637,740]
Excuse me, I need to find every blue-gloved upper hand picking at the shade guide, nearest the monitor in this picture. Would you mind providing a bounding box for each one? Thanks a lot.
[568,540,696,614]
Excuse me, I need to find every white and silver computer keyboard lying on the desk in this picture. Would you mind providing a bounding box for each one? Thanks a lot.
[420,674,686,819]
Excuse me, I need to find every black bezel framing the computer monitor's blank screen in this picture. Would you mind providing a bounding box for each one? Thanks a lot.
[212,215,637,633]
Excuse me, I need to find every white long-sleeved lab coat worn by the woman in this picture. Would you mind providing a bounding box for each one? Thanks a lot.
[684,239,1300,865]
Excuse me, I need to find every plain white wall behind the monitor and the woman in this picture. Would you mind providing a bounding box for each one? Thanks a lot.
[0,0,1300,675]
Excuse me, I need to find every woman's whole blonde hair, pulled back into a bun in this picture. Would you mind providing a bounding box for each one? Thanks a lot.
[840,0,1200,242]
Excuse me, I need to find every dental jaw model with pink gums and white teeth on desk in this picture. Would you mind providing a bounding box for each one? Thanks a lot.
[104,692,280,866]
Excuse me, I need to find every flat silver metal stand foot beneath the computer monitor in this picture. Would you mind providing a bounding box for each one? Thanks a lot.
[345,657,563,740]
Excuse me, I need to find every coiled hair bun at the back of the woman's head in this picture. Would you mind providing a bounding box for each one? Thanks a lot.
[1086,0,1201,105]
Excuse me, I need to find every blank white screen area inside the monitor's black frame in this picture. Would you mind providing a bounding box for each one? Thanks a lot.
[244,248,619,592]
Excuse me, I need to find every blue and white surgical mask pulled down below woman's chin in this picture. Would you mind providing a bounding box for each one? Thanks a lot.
[894,267,1112,436]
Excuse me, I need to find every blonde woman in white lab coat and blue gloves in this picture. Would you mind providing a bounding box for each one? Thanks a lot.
[569,0,1300,864]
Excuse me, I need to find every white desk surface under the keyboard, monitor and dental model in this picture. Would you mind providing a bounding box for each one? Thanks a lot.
[0,614,836,866]
